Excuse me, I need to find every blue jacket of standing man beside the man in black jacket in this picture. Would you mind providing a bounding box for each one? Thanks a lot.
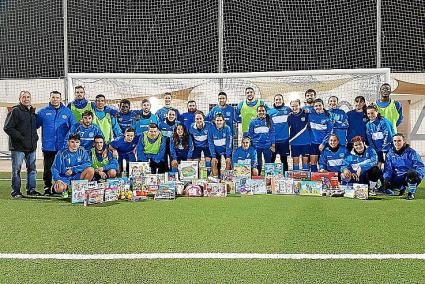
[37,103,75,152]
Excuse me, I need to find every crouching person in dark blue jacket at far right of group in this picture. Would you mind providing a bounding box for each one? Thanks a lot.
[384,133,425,200]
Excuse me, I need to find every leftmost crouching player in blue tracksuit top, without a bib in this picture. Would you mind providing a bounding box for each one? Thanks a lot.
[52,134,94,197]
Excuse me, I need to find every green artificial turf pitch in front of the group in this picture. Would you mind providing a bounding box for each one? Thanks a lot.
[0,175,425,283]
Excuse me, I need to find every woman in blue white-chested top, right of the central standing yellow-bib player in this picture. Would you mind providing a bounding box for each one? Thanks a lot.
[248,106,276,174]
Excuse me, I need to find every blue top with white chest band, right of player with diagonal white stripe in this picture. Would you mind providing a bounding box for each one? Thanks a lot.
[308,111,332,145]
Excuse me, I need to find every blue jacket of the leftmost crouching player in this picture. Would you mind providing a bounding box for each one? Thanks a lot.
[52,147,91,183]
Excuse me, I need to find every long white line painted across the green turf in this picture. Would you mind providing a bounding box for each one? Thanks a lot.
[0,253,425,260]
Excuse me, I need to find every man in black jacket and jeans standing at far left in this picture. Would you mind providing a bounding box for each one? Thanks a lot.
[3,91,40,198]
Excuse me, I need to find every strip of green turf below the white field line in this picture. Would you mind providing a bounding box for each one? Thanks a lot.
[0,260,425,283]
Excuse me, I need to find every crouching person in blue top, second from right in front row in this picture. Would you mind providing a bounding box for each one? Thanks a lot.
[341,136,384,194]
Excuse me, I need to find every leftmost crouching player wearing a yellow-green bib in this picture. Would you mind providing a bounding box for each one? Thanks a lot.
[91,135,118,181]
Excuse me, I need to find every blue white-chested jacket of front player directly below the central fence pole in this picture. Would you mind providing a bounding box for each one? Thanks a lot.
[208,125,233,158]
